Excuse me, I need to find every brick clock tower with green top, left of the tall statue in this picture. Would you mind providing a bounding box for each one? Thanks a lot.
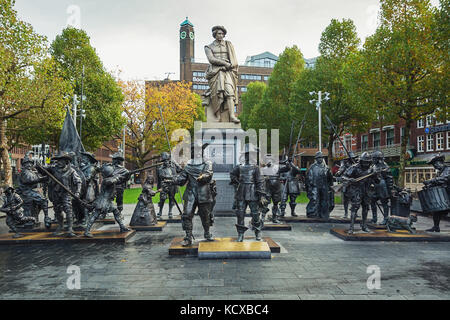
[179,17,195,81]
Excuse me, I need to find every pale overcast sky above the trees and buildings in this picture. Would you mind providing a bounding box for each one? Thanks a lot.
[15,0,438,80]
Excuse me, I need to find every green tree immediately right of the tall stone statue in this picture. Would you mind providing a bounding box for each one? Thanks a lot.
[248,45,305,151]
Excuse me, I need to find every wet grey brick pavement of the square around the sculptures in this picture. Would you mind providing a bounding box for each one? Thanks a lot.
[0,205,450,300]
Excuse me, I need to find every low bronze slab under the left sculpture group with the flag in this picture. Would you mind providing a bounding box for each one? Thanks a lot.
[0,230,136,245]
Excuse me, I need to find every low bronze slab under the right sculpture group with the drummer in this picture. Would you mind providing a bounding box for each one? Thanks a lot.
[330,228,450,242]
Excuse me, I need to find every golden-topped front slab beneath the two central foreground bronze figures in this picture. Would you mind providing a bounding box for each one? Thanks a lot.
[198,238,272,260]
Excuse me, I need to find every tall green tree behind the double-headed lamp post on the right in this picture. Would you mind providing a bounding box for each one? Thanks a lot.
[291,19,370,164]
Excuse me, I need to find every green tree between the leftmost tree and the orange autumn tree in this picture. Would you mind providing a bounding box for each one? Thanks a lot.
[51,27,125,151]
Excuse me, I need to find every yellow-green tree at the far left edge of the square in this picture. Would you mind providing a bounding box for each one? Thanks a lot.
[0,0,68,184]
